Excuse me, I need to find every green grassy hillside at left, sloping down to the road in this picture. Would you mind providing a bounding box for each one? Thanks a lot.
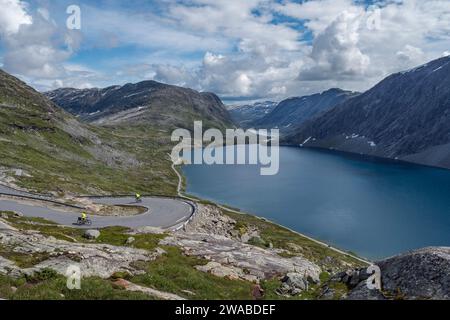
[0,70,177,194]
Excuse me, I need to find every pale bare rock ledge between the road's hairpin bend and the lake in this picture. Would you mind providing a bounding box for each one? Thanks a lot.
[160,205,321,292]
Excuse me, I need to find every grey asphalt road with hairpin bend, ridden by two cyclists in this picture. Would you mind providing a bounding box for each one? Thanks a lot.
[0,185,196,229]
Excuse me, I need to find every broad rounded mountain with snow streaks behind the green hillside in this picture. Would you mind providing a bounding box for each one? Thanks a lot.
[46,81,232,128]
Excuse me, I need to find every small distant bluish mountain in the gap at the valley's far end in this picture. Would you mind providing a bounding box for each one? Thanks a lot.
[227,101,278,128]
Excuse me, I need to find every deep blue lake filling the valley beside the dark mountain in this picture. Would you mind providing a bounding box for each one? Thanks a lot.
[183,147,450,259]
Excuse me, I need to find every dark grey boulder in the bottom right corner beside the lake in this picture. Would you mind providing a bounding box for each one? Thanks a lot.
[332,247,450,300]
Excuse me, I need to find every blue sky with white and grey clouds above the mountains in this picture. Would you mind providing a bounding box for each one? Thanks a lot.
[0,0,450,103]
